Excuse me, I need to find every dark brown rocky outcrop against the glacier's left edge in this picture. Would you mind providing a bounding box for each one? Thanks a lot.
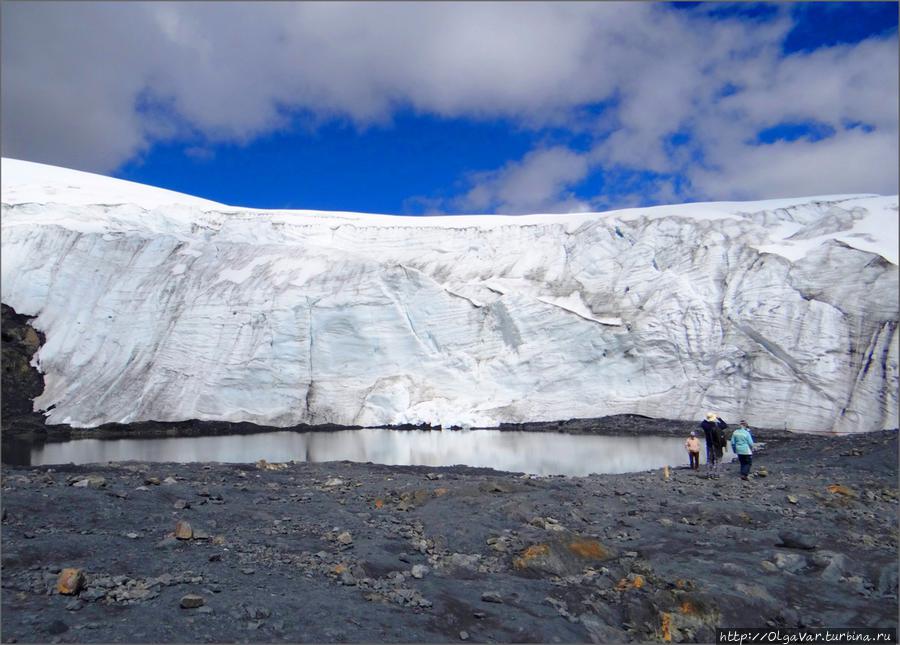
[0,305,44,436]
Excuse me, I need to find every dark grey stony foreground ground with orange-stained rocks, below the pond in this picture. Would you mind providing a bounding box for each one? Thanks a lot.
[2,431,898,643]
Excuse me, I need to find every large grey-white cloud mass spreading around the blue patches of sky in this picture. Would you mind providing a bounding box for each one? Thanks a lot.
[0,1,898,206]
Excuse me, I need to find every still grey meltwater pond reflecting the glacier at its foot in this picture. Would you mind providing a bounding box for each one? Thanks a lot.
[3,428,716,476]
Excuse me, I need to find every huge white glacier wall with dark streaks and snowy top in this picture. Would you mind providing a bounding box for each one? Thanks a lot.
[0,159,900,432]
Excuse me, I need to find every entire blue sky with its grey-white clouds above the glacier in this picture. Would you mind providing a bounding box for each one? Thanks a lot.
[0,0,898,215]
